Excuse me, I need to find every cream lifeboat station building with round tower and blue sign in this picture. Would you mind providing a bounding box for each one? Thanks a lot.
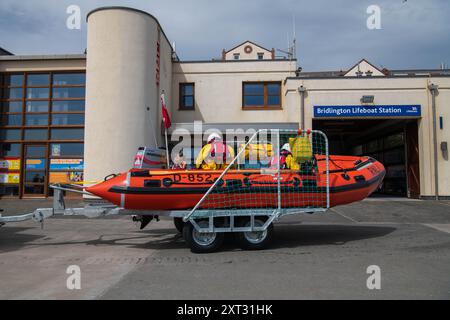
[0,7,450,199]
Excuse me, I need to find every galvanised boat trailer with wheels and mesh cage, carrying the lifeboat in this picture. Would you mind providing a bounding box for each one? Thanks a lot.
[0,130,330,253]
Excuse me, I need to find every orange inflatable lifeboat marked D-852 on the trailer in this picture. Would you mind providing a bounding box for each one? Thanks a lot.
[86,155,385,210]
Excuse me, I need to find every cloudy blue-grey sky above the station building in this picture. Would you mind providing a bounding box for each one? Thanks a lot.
[0,0,450,71]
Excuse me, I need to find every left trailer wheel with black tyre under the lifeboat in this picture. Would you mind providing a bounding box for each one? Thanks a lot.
[183,220,224,253]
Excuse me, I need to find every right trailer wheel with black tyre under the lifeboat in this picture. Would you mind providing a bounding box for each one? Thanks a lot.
[237,218,273,250]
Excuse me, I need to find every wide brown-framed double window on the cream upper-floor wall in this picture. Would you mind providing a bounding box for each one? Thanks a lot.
[242,82,281,109]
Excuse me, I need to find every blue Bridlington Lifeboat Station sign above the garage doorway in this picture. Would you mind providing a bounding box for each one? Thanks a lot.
[314,105,421,118]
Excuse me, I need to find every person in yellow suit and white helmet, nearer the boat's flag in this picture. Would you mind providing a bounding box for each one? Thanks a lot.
[195,133,234,170]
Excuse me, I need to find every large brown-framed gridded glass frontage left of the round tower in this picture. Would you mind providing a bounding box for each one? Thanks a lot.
[0,71,86,196]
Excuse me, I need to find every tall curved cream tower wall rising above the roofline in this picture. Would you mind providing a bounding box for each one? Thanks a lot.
[85,8,171,181]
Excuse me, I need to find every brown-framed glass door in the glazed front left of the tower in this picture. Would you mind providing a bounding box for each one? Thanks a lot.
[23,144,47,197]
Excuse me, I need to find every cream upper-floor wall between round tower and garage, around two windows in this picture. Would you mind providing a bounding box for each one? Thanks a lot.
[172,60,298,123]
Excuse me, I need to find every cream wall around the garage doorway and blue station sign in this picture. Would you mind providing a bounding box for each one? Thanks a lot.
[286,77,450,196]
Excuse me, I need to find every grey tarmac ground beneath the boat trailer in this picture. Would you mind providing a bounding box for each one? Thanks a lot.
[0,199,450,299]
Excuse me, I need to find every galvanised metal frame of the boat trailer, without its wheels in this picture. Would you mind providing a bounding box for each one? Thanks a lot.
[0,129,330,249]
